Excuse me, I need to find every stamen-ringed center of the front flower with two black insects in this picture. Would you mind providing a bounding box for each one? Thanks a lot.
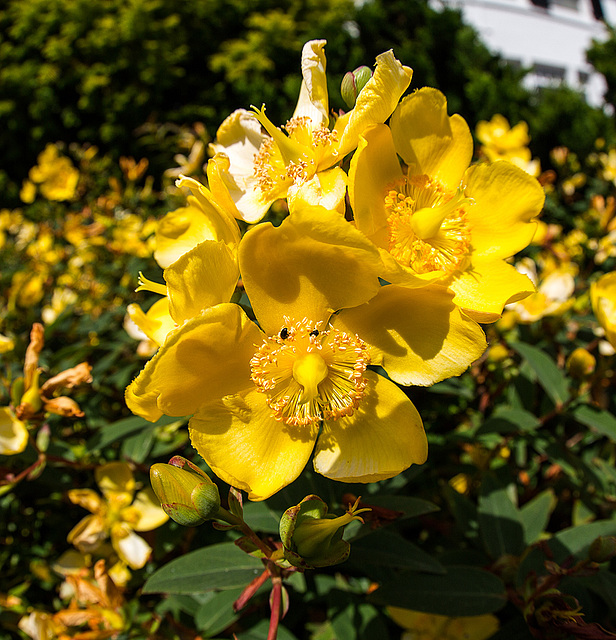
[250,317,370,426]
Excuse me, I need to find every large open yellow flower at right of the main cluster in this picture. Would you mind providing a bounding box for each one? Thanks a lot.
[349,88,544,322]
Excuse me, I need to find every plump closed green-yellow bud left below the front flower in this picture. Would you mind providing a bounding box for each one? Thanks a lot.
[150,456,220,527]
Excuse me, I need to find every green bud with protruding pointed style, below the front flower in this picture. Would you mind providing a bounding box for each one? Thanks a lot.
[280,495,370,569]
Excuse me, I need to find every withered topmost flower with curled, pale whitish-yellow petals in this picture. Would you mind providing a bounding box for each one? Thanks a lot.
[207,40,412,222]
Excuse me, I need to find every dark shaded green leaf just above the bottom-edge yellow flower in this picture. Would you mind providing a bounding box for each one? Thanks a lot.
[368,566,507,616]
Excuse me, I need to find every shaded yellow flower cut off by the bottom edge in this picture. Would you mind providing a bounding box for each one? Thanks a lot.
[387,607,499,640]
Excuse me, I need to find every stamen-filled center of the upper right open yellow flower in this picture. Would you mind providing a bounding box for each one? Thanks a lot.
[385,175,473,275]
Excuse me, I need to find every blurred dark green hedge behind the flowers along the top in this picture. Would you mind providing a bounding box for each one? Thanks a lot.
[0,0,614,198]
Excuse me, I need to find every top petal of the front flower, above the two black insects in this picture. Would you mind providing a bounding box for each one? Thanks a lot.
[239,207,380,335]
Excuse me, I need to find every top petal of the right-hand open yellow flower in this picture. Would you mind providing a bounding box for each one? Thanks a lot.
[391,87,473,189]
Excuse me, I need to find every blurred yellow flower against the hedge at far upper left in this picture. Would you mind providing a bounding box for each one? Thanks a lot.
[27,144,79,202]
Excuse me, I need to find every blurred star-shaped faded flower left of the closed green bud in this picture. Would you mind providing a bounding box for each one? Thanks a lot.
[67,462,168,569]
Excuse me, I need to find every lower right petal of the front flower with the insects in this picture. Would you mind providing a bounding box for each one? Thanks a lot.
[314,371,428,482]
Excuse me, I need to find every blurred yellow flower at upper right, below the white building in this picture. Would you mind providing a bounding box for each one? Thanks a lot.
[475,113,541,178]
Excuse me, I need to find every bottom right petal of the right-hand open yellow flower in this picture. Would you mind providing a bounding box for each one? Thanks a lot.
[449,258,535,322]
